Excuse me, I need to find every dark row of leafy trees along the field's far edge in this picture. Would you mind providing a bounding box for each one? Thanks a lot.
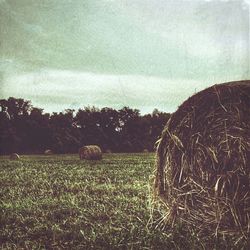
[0,97,170,154]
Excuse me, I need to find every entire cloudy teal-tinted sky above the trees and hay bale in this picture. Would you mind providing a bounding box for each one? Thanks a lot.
[0,0,250,113]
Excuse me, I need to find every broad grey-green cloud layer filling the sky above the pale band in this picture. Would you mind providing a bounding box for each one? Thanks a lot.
[0,0,249,79]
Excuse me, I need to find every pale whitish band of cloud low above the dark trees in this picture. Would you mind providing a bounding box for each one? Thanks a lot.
[2,70,215,113]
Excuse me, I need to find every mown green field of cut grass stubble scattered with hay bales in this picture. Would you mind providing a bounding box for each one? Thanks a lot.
[0,153,245,249]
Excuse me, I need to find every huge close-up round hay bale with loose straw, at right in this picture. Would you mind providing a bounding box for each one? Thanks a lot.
[155,81,250,238]
